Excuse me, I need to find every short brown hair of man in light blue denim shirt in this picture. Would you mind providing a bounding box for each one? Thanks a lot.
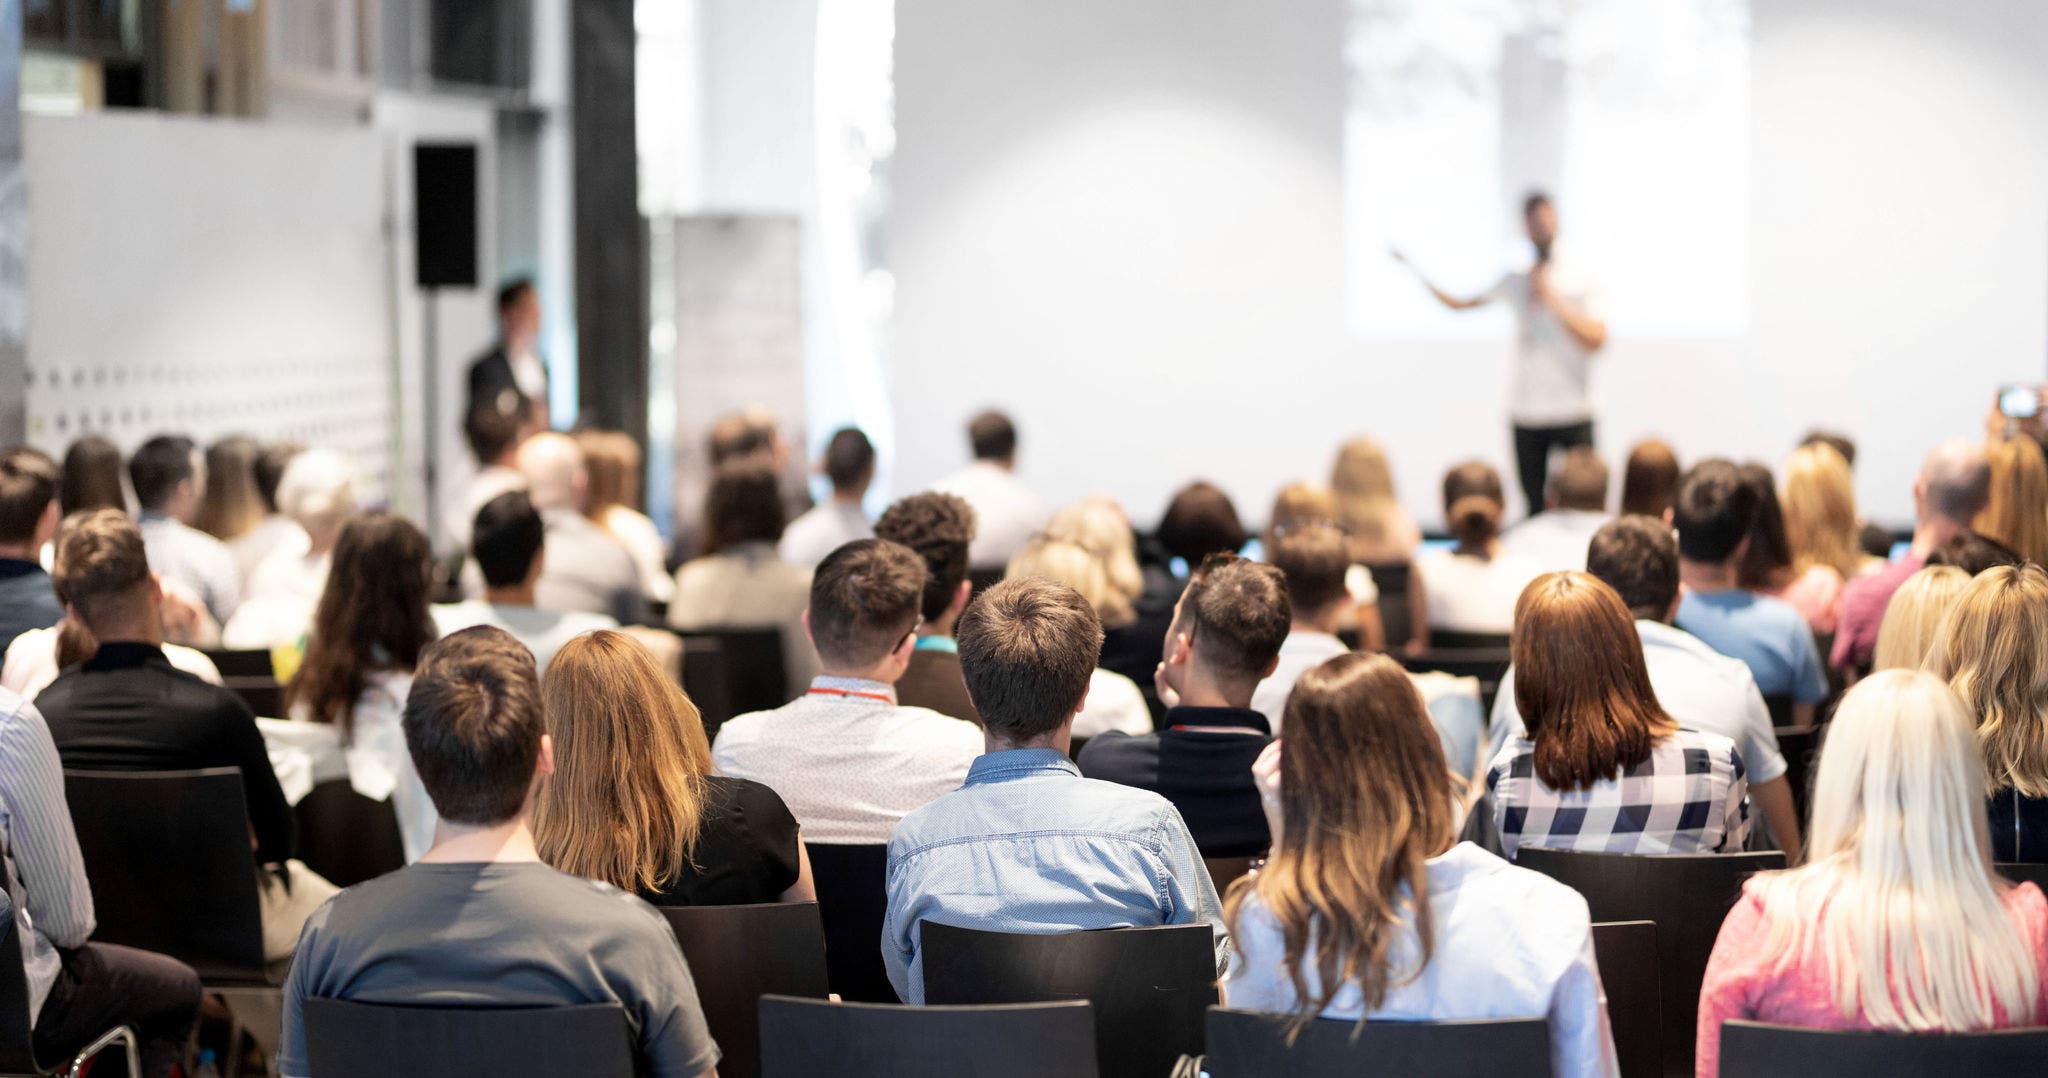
[958,576,1102,744]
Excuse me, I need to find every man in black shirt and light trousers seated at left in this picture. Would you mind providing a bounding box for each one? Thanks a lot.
[37,508,334,961]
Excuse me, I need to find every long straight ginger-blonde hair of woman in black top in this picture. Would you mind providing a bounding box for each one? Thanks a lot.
[532,629,711,892]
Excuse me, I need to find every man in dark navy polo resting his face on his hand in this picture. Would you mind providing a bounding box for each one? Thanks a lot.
[1073,553,1294,857]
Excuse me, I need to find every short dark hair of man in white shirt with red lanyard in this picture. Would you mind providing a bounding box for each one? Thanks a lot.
[811,539,926,666]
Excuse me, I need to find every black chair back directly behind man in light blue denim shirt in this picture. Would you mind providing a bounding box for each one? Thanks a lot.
[918,920,1217,1076]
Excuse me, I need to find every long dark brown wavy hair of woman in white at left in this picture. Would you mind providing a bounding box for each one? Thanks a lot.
[285,512,438,742]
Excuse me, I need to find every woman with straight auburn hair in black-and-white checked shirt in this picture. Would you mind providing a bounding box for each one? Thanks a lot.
[1487,573,1749,859]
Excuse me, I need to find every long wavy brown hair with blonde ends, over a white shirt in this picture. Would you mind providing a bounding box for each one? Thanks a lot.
[1223,652,1458,1035]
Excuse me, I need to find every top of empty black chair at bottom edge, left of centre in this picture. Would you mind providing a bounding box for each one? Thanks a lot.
[762,996,1105,1078]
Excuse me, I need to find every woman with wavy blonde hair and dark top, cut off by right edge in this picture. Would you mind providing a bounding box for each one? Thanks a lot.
[1925,566,2048,863]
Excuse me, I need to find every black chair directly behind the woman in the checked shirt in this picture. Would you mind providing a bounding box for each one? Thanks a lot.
[1516,846,1786,1072]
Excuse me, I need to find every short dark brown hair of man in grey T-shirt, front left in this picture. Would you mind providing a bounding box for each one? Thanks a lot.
[403,625,547,826]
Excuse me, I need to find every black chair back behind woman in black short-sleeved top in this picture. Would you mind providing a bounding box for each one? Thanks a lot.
[662,902,825,1078]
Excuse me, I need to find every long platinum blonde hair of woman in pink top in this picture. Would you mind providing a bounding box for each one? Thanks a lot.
[1749,670,2040,1031]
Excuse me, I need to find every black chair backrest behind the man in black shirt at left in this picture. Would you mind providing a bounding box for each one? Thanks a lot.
[63,766,264,980]
